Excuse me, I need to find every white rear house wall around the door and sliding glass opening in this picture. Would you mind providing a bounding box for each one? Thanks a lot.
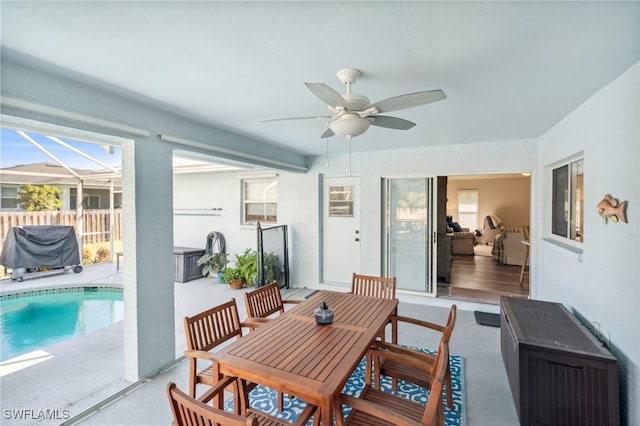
[174,139,538,287]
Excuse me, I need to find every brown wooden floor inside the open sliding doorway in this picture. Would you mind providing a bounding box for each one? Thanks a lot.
[438,248,529,304]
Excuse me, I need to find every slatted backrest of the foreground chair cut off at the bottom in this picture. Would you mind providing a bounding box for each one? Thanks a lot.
[167,382,258,426]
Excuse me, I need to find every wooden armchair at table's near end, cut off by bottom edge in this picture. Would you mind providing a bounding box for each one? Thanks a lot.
[167,376,318,426]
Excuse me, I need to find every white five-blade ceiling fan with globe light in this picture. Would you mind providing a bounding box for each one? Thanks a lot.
[263,68,447,140]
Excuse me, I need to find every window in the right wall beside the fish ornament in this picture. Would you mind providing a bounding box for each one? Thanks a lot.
[551,158,584,242]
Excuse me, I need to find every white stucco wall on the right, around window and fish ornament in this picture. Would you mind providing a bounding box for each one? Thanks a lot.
[532,64,640,425]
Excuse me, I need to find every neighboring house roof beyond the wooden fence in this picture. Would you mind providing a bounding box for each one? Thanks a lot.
[0,163,122,187]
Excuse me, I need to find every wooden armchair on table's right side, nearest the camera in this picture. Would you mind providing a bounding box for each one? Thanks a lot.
[335,338,449,426]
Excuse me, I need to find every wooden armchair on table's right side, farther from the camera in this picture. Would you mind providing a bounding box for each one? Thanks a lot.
[369,305,457,409]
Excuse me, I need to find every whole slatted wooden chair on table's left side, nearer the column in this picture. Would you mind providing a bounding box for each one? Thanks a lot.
[184,299,262,407]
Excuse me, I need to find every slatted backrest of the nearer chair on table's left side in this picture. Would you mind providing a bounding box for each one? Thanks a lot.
[184,299,242,351]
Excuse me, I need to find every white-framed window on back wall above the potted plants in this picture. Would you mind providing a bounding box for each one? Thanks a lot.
[242,177,278,224]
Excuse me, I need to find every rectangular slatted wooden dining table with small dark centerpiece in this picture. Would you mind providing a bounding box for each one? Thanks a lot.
[216,291,398,425]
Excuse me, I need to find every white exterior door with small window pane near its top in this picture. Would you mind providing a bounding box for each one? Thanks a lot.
[322,177,361,284]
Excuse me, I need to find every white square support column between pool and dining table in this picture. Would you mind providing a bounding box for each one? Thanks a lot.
[122,137,175,381]
